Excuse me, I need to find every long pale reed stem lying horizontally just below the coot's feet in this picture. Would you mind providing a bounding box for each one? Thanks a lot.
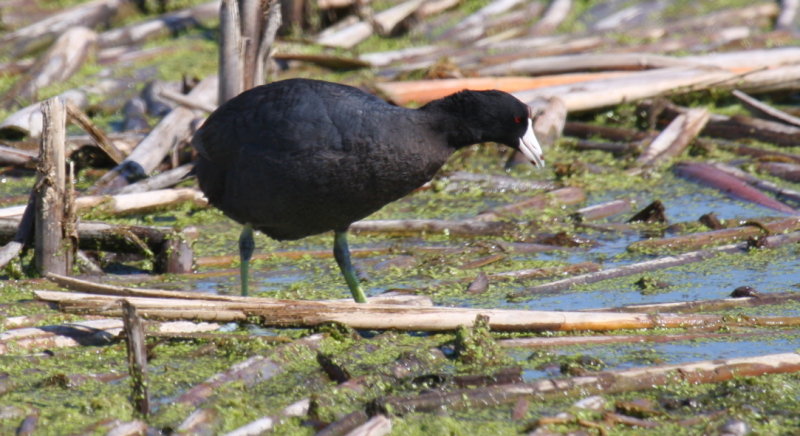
[35,291,800,331]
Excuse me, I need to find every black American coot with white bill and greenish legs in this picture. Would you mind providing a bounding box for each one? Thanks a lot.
[192,79,544,302]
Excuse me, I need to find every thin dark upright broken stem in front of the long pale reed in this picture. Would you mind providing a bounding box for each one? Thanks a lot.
[122,300,150,416]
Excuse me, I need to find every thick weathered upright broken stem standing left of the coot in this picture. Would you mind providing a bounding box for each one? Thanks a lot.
[34,97,73,275]
